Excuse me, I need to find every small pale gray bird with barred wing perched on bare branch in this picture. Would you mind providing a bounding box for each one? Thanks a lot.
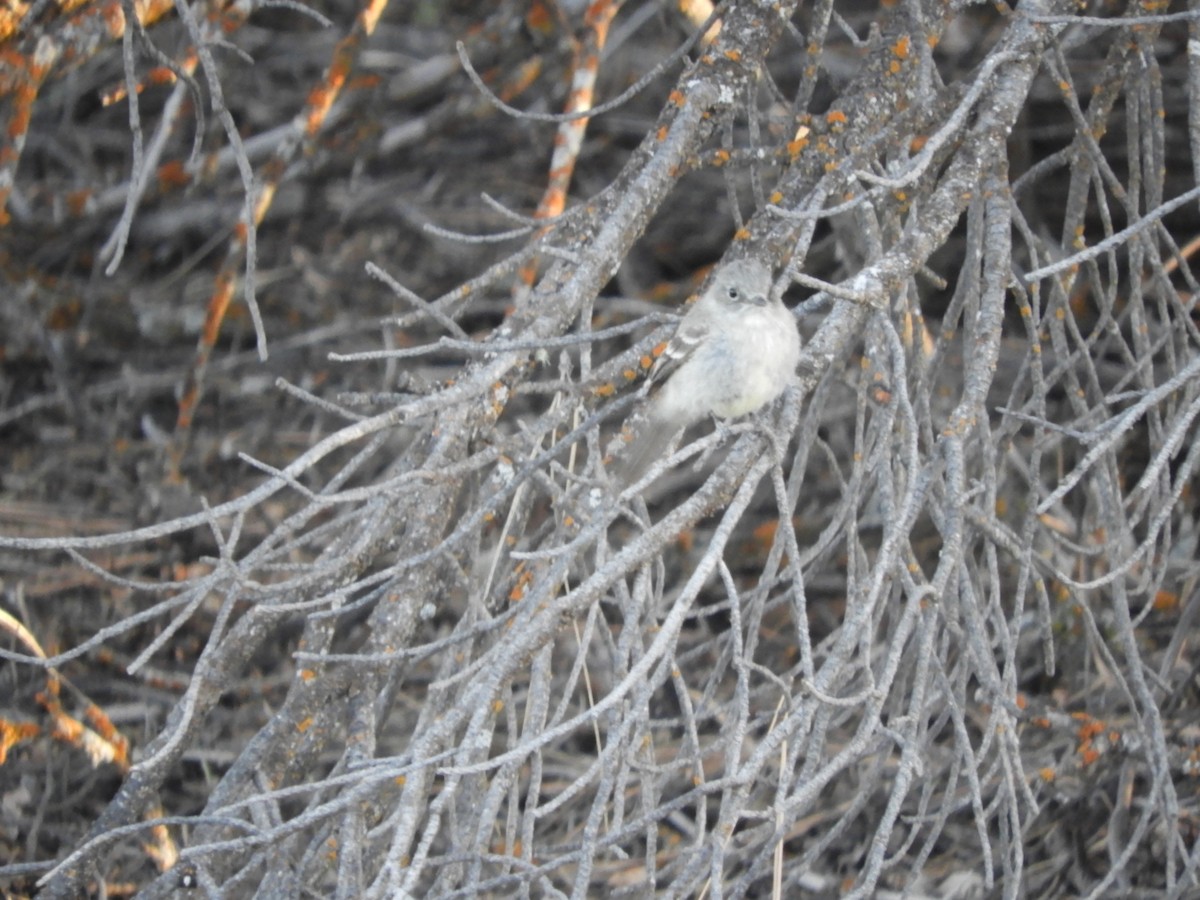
[617,259,800,485]
